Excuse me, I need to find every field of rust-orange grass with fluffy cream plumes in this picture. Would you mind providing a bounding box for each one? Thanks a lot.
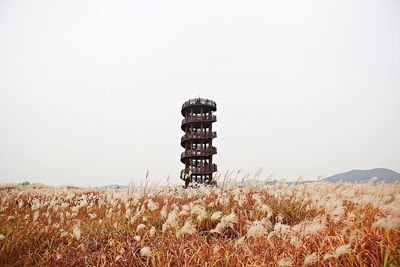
[0,182,400,266]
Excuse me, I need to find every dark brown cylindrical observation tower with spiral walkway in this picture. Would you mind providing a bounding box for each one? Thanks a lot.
[181,98,217,187]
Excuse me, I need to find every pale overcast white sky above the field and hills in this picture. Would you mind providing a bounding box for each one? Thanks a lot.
[0,0,400,186]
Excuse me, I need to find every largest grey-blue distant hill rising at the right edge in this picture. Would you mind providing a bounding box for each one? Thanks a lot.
[324,168,400,183]
